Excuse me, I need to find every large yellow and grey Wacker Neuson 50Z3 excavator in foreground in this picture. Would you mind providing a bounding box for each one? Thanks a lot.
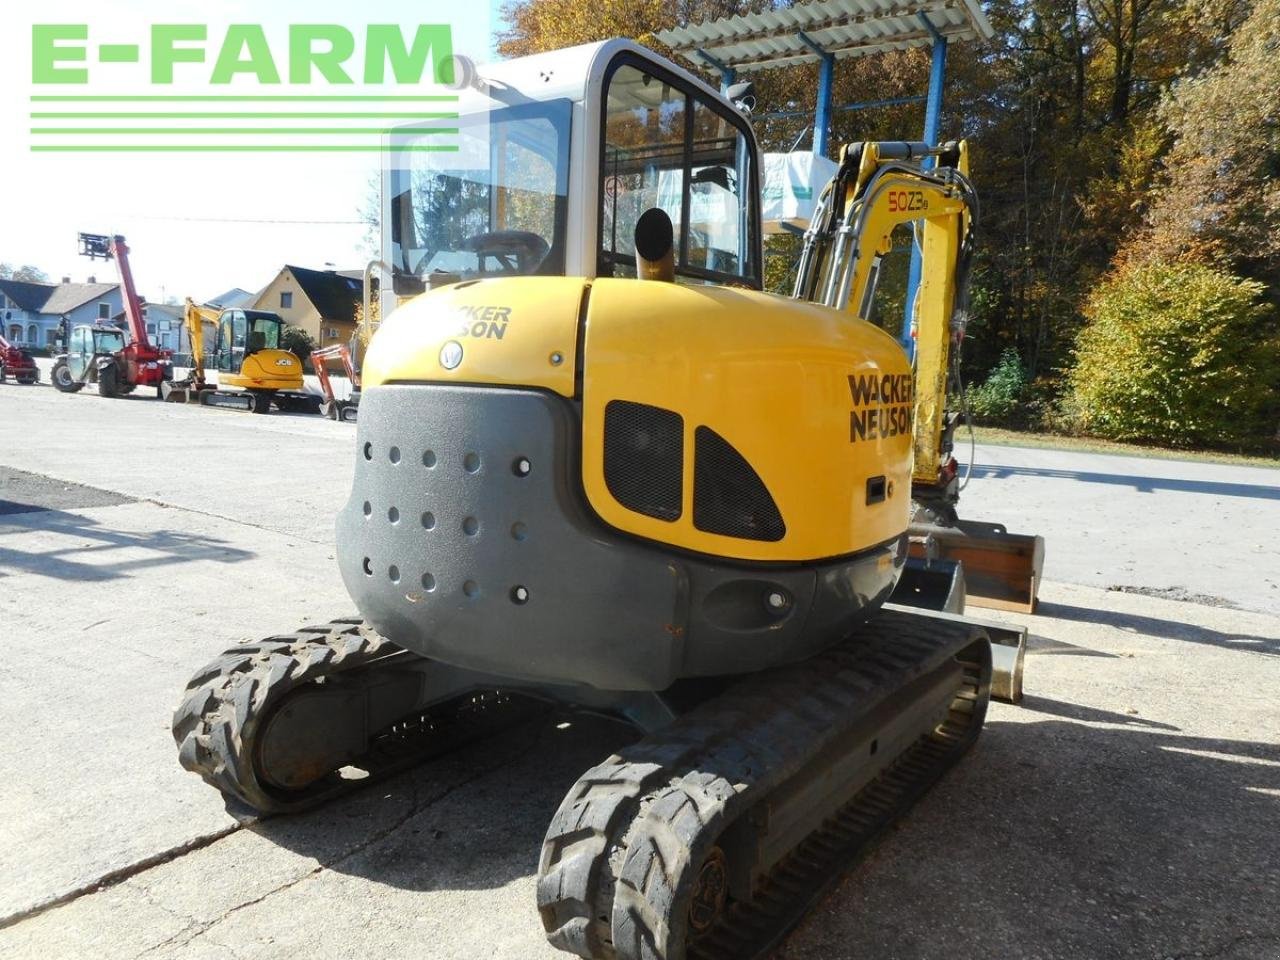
[173,41,1025,960]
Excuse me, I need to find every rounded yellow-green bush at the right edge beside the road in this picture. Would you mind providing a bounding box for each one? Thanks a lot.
[1070,262,1280,447]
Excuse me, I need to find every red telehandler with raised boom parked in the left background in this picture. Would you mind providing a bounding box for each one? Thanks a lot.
[51,233,173,397]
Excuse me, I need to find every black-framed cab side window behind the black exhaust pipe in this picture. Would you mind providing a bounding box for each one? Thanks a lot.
[599,63,759,285]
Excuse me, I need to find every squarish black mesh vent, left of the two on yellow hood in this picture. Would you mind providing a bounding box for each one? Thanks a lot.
[604,401,685,520]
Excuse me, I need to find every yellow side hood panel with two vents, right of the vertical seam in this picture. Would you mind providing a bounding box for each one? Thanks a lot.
[582,279,911,562]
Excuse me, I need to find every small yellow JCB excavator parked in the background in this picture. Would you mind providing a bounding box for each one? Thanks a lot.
[161,297,320,413]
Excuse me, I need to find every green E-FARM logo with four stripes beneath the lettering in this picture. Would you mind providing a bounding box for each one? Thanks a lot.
[31,23,462,152]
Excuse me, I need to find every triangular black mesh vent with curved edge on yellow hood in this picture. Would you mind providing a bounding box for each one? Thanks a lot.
[694,426,787,540]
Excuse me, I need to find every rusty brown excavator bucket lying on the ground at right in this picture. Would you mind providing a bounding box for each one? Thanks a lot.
[910,520,1044,613]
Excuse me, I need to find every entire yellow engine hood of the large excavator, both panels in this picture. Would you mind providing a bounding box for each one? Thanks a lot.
[365,276,914,562]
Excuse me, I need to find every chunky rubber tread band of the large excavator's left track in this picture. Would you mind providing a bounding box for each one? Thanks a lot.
[173,617,399,813]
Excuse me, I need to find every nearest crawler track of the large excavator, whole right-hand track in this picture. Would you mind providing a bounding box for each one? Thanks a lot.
[538,613,991,960]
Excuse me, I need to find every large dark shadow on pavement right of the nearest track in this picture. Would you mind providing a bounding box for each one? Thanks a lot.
[776,716,1280,960]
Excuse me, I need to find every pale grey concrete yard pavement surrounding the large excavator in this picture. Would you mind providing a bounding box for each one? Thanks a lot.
[0,384,1280,960]
